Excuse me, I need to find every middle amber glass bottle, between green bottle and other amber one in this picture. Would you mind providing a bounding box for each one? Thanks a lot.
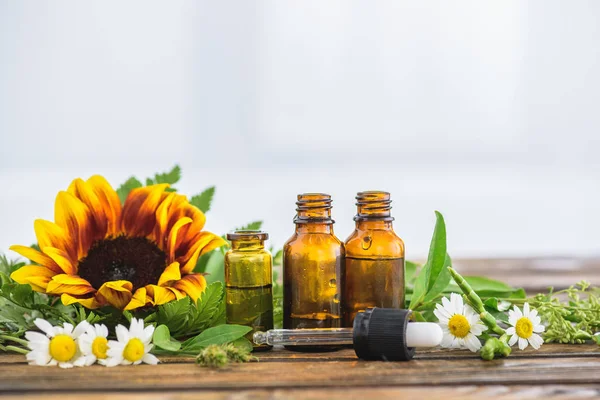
[283,193,344,350]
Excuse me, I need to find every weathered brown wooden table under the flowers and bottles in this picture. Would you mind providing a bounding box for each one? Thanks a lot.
[0,259,600,400]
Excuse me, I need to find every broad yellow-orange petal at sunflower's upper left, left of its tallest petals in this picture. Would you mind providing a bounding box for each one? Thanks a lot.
[54,192,95,260]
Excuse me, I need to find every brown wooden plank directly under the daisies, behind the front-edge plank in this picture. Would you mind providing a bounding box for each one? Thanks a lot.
[0,357,600,392]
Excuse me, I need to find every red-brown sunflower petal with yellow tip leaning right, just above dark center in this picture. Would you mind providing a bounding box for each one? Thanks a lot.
[122,183,169,238]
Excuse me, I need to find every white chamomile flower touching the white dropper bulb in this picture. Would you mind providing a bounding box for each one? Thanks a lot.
[433,293,487,352]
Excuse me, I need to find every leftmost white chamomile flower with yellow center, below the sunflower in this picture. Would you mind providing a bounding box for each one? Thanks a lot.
[25,318,89,368]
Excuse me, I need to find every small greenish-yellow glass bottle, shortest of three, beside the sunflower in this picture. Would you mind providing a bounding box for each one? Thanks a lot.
[225,230,273,351]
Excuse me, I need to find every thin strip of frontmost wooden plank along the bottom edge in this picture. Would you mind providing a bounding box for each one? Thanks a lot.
[0,385,600,400]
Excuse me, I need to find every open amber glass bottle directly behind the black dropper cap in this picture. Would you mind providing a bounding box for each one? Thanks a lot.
[342,192,404,327]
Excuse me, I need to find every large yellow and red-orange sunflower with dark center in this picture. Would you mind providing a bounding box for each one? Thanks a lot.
[11,176,226,310]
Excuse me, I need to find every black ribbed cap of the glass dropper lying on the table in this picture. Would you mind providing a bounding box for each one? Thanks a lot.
[353,308,415,361]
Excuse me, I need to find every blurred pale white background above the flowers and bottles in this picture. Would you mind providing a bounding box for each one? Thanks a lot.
[0,0,600,258]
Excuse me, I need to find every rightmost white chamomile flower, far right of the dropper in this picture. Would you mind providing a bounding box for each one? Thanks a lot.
[506,303,546,350]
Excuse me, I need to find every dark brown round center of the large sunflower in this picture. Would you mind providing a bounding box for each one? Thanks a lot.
[79,236,167,290]
